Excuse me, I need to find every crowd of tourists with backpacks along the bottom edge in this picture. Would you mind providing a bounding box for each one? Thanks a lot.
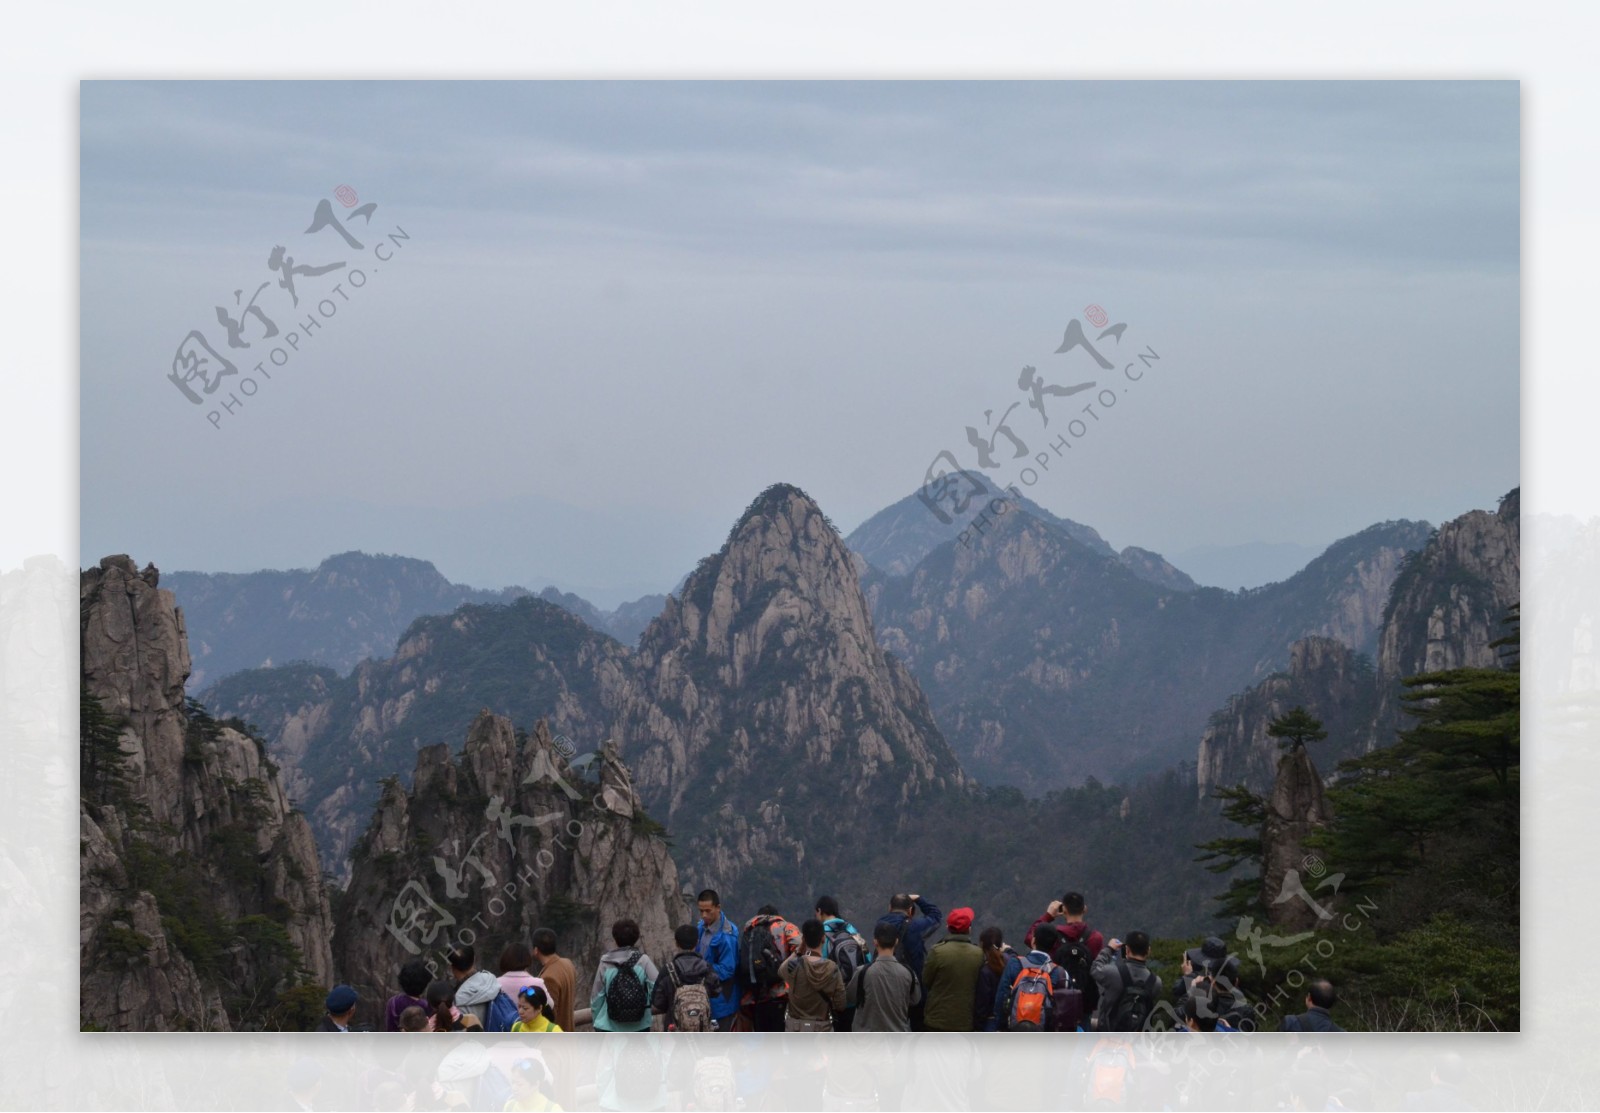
[320,889,1341,1033]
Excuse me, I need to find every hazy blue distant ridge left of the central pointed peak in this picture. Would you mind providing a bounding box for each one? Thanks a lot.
[163,552,666,691]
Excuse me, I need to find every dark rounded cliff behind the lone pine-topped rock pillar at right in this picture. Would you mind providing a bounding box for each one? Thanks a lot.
[1195,638,1378,796]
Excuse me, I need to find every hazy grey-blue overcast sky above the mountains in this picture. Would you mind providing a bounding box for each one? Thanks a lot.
[80,82,1518,604]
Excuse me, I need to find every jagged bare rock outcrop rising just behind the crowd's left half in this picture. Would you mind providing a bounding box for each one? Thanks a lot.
[334,712,691,1022]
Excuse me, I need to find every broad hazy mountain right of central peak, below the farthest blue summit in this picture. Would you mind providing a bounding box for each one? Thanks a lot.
[869,507,1429,792]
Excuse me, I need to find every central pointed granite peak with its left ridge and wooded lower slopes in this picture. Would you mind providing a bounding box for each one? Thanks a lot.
[205,486,1218,927]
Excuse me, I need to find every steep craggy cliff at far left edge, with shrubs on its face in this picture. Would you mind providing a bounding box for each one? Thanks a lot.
[78,557,333,1030]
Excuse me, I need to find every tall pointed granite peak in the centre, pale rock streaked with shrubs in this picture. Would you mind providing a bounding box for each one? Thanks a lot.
[616,485,966,908]
